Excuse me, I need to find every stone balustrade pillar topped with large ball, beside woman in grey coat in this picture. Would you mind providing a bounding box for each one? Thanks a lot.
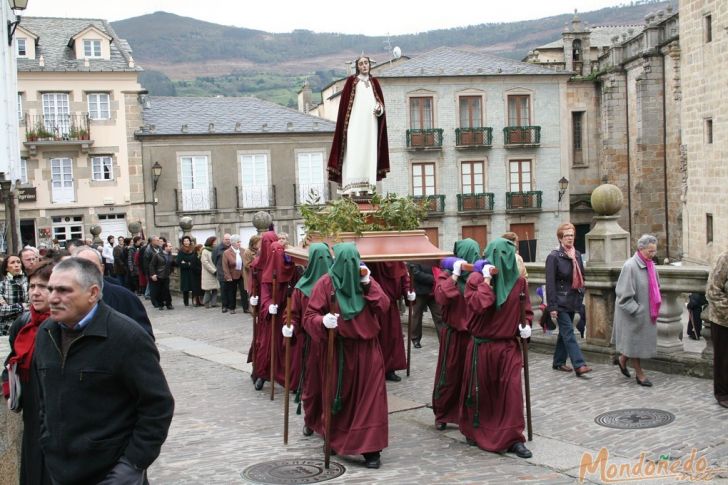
[584,184,629,347]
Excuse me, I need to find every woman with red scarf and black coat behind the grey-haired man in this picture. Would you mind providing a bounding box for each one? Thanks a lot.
[3,260,54,485]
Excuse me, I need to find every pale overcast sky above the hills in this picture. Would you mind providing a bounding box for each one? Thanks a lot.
[24,0,629,35]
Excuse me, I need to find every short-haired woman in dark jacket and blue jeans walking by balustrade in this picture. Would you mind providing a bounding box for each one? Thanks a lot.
[545,222,592,377]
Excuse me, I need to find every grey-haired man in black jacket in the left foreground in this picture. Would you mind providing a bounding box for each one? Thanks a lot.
[34,258,174,485]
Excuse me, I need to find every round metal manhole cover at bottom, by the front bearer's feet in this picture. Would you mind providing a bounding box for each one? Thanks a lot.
[242,459,346,485]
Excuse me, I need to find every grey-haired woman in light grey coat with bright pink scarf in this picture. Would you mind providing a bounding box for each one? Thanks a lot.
[612,234,662,387]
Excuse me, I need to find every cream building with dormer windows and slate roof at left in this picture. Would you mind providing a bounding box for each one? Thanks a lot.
[15,17,144,245]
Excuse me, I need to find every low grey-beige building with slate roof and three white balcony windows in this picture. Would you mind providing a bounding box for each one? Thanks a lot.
[136,97,335,244]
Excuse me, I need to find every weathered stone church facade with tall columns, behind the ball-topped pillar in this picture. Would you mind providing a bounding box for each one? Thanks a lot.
[528,8,685,260]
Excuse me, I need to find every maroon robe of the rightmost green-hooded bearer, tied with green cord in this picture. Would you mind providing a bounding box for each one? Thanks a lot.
[460,273,533,452]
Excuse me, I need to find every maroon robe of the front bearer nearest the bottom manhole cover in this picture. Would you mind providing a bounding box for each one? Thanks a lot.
[303,274,389,455]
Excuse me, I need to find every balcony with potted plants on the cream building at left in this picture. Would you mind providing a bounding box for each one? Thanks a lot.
[23,113,93,155]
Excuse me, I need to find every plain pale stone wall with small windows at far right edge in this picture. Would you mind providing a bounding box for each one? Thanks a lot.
[679,0,728,264]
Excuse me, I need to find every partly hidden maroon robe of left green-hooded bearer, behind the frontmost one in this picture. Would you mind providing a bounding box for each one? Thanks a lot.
[291,288,325,435]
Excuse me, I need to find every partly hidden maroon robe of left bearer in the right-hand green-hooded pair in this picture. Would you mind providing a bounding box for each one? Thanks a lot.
[432,271,470,423]
